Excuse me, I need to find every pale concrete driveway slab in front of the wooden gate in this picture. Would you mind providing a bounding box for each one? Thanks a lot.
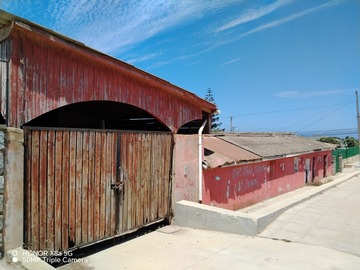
[60,226,360,270]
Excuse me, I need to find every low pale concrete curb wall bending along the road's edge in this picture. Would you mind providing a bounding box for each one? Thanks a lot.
[173,170,360,236]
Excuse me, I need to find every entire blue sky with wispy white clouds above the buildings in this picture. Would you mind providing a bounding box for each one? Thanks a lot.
[0,0,360,132]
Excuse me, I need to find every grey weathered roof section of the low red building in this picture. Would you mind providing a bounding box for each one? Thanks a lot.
[217,133,331,158]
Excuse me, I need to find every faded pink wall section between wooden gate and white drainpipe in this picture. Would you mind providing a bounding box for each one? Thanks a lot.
[172,135,199,205]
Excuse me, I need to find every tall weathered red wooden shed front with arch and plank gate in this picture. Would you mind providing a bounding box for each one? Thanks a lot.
[0,11,216,255]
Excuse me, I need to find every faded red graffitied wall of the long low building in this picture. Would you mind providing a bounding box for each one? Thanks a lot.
[202,151,331,210]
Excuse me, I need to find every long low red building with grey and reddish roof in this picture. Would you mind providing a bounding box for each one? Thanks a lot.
[202,133,332,210]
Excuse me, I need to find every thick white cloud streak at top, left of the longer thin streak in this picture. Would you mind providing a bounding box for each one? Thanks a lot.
[214,0,292,32]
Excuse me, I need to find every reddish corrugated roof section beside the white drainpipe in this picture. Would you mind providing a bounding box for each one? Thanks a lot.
[203,136,261,168]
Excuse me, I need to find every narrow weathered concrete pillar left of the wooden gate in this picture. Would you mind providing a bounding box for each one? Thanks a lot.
[0,126,24,257]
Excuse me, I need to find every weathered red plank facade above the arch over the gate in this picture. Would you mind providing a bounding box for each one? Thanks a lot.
[0,16,216,132]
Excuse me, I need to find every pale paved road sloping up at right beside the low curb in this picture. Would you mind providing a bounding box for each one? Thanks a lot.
[258,174,360,256]
